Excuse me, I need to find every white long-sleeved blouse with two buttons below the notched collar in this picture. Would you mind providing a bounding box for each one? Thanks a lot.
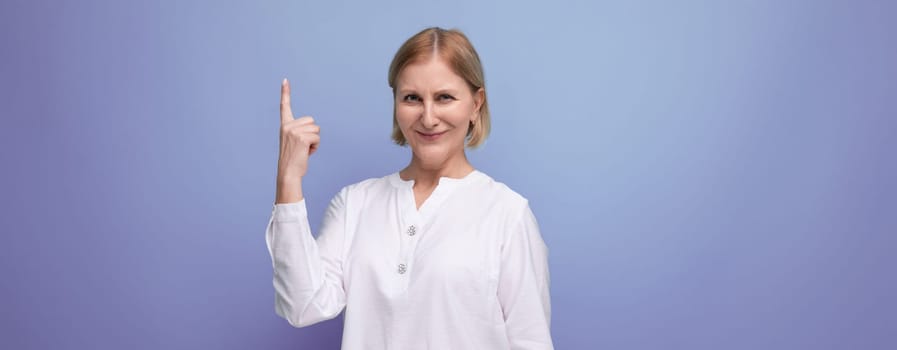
[265,170,553,350]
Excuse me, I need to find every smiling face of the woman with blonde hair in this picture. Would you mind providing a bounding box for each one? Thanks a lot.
[395,56,484,167]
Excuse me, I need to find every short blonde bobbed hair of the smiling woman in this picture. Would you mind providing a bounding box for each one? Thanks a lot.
[389,27,490,148]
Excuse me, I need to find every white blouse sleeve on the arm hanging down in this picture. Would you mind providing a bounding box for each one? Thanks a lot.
[498,205,554,350]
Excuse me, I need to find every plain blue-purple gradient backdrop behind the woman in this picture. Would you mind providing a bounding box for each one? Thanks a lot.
[0,0,897,349]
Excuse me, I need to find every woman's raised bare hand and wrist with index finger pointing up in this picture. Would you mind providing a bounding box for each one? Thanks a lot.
[275,79,321,203]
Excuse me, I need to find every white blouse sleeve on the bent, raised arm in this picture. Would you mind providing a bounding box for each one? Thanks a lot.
[265,189,346,327]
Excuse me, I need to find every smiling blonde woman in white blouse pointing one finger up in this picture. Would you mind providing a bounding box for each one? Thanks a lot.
[266,28,552,349]
